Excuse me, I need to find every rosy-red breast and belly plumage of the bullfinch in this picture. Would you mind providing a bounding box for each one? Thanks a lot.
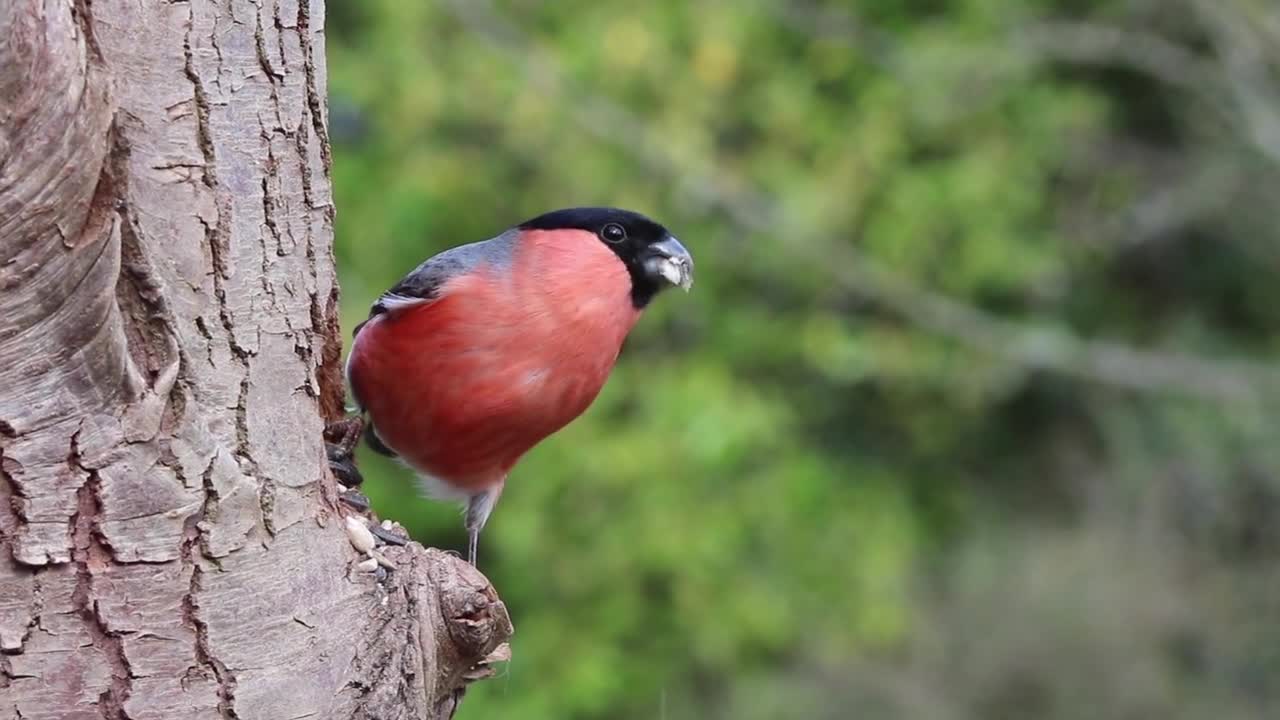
[347,229,640,492]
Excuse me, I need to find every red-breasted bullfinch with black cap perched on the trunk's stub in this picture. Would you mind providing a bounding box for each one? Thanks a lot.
[346,208,694,565]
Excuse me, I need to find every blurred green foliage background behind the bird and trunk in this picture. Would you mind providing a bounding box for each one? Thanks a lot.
[328,0,1280,720]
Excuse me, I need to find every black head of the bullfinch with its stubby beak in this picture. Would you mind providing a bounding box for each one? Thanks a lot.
[520,208,694,309]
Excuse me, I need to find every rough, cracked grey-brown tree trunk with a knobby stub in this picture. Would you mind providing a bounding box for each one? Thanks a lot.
[0,0,511,720]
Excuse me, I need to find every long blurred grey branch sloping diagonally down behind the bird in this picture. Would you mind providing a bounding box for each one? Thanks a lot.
[449,0,1280,404]
